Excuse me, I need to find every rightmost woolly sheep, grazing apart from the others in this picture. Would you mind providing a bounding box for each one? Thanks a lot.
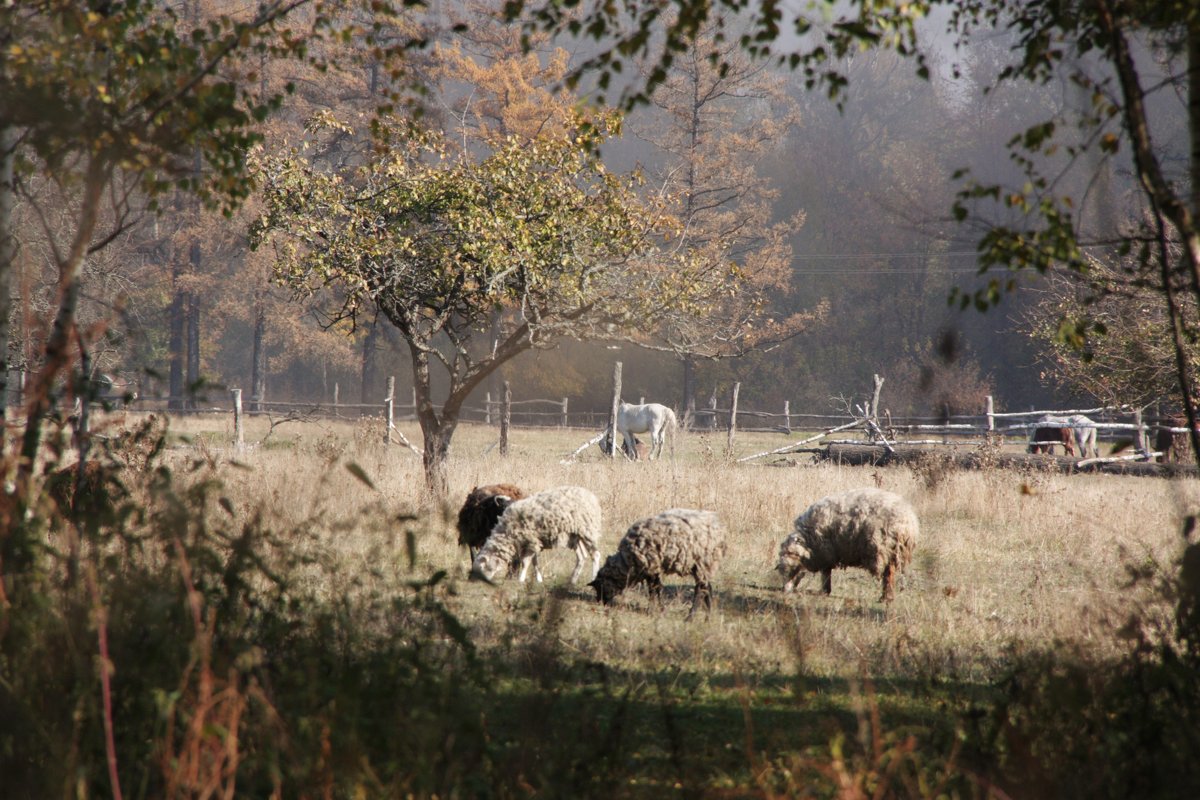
[776,488,920,601]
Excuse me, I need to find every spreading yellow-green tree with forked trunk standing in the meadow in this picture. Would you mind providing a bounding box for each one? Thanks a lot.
[258,115,738,497]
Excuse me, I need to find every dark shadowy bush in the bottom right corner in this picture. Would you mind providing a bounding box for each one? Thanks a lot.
[972,521,1200,798]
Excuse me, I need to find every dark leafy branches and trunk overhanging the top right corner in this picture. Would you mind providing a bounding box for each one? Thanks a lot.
[506,0,1200,438]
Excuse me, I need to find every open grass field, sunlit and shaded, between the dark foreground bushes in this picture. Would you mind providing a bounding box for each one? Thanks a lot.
[129,417,1200,798]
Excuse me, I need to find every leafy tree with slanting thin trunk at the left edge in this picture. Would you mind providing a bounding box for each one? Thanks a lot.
[0,0,427,585]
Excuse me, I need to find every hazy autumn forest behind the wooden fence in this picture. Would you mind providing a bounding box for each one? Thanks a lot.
[10,2,1161,422]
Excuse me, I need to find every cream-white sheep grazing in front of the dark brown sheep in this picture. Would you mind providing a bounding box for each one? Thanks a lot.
[470,486,601,583]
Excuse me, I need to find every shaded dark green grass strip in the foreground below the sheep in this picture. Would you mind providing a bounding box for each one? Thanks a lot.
[475,662,988,798]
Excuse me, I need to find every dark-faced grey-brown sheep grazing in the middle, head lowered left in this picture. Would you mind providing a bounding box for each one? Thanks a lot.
[588,509,726,619]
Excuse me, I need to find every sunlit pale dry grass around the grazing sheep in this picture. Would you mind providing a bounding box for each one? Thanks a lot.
[147,417,1200,681]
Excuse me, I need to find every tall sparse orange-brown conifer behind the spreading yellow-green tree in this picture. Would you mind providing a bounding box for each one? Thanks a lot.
[632,15,821,417]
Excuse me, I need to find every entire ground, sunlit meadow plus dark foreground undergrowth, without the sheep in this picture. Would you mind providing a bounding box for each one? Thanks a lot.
[0,415,1200,798]
